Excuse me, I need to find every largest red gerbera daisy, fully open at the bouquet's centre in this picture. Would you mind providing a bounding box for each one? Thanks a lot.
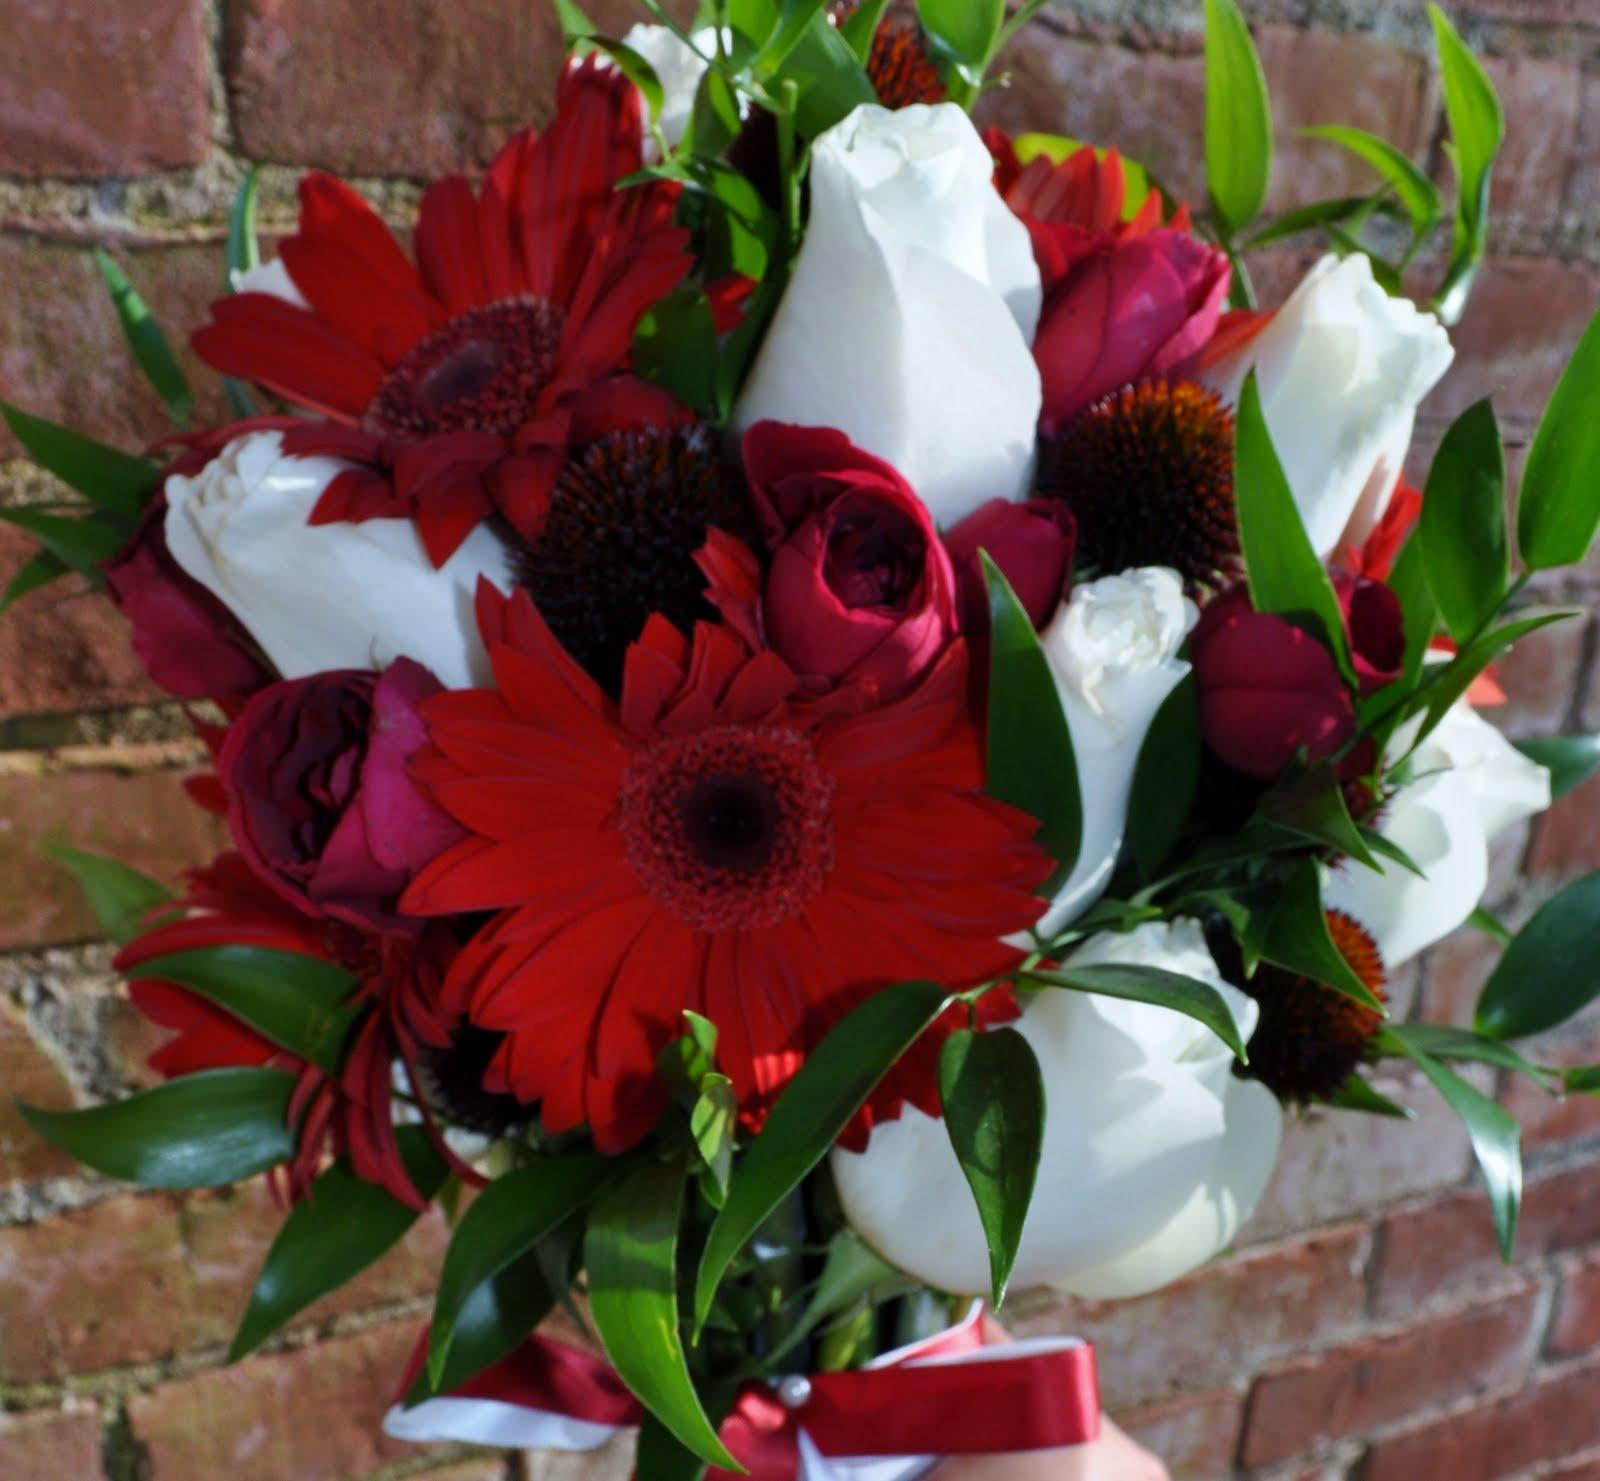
[403,587,1050,1152]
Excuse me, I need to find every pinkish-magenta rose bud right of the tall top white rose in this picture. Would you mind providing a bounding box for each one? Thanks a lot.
[1034,226,1232,430]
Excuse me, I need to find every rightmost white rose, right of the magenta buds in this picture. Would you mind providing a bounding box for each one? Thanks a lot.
[1323,699,1550,969]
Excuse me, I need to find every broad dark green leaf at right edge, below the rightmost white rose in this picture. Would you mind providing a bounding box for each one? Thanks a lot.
[1475,872,1600,1038]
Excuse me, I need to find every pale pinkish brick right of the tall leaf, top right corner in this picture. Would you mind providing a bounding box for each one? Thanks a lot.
[1485,56,1582,229]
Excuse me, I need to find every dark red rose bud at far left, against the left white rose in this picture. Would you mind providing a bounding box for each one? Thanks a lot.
[104,494,272,699]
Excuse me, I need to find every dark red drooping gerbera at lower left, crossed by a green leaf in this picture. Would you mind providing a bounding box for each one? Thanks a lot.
[115,854,467,1208]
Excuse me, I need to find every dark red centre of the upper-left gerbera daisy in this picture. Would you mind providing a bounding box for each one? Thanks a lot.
[366,299,566,438]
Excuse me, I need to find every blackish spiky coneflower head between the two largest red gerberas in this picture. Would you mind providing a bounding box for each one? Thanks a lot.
[522,424,755,693]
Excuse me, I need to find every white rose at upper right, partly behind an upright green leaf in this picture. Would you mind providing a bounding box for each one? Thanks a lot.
[1200,253,1456,557]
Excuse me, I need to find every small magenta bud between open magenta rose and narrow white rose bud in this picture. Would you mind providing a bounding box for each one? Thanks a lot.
[944,499,1077,633]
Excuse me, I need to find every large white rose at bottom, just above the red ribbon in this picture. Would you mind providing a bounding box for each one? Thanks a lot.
[832,921,1282,1295]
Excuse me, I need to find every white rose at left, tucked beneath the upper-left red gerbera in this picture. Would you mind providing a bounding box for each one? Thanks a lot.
[166,432,510,689]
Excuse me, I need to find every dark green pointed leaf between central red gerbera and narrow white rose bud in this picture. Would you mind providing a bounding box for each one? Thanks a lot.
[984,552,1083,899]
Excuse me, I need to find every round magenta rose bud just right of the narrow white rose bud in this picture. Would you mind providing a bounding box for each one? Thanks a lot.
[1189,587,1355,780]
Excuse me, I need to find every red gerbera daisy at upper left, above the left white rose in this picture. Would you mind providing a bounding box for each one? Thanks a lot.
[194,56,691,563]
